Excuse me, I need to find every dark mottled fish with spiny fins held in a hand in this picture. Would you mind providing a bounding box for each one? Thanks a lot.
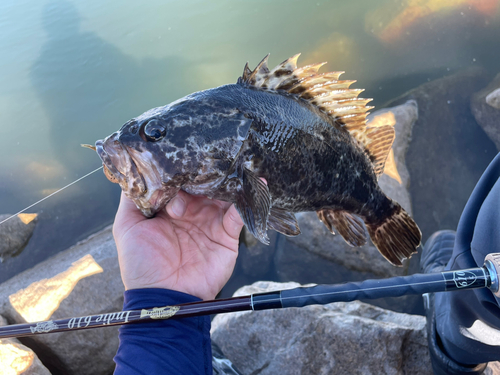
[94,54,422,266]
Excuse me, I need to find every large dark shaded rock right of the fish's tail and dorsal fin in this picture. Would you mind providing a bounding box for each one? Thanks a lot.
[387,68,497,240]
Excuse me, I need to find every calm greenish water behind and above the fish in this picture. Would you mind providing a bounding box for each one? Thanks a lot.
[0,0,500,296]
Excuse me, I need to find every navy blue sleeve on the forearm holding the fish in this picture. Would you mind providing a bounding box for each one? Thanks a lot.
[114,289,212,375]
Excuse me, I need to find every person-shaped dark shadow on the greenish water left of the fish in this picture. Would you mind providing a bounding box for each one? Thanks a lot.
[30,0,193,173]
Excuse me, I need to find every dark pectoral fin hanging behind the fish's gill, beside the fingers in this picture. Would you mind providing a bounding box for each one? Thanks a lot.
[234,168,271,245]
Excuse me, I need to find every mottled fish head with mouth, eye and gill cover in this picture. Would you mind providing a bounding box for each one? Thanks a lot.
[96,93,251,217]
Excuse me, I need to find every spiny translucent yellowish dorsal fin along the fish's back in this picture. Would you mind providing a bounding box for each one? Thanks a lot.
[238,53,395,176]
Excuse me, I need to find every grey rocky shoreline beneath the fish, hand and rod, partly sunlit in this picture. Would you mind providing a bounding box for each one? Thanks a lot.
[0,69,500,375]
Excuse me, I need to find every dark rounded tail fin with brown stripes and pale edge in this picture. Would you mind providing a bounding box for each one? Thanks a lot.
[366,206,422,266]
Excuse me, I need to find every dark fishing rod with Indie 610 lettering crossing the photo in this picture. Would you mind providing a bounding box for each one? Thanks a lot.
[0,253,500,339]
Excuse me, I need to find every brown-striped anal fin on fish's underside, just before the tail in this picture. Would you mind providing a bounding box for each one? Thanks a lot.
[316,208,366,246]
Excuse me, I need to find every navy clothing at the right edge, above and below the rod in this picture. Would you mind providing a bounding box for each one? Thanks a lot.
[435,154,500,365]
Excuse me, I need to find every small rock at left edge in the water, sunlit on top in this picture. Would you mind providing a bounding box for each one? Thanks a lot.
[0,214,38,262]
